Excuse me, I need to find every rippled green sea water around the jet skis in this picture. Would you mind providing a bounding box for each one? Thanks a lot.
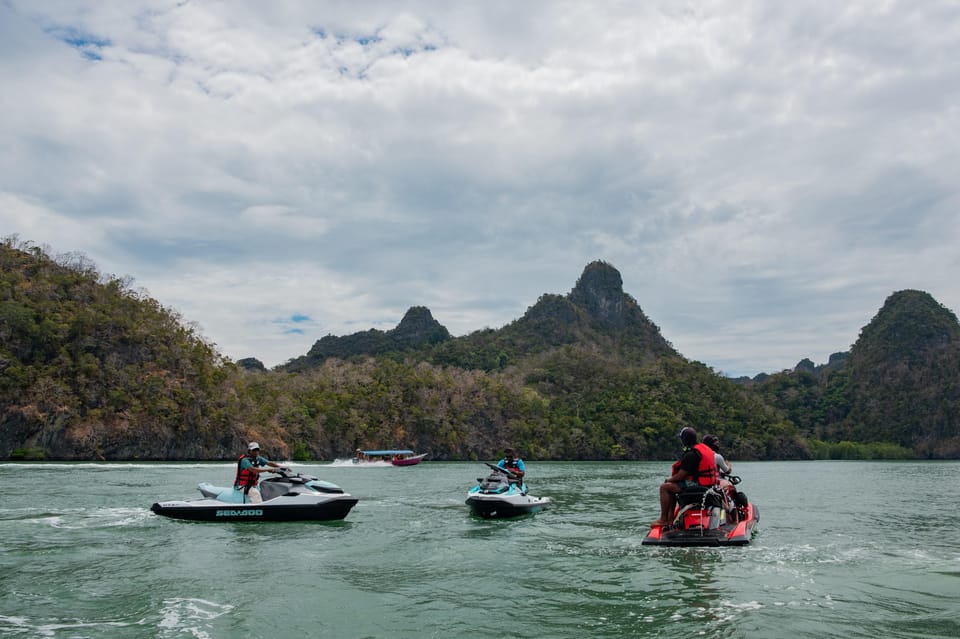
[0,461,960,639]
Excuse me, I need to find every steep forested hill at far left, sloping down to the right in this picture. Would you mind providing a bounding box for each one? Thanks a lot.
[0,238,244,459]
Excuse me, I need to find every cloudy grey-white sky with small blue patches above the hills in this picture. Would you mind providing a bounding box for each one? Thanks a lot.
[0,0,960,377]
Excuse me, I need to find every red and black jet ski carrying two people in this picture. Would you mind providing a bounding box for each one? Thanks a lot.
[641,475,760,546]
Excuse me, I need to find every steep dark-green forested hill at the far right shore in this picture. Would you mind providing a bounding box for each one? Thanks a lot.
[751,290,960,459]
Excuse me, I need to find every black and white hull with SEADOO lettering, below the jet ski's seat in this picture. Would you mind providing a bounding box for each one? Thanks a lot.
[150,496,359,522]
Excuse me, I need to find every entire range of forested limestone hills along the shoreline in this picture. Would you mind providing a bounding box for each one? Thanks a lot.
[0,238,957,460]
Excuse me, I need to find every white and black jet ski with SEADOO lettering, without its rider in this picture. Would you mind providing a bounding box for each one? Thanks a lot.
[150,469,358,521]
